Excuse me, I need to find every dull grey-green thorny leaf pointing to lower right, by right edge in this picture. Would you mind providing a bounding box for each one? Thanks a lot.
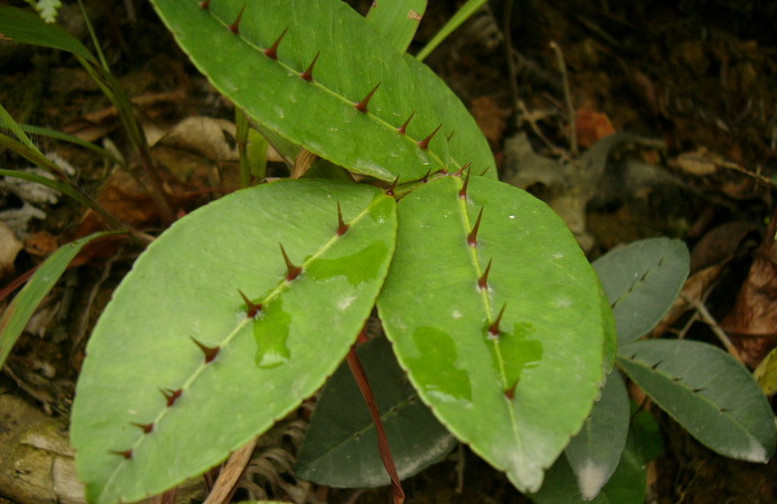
[618,340,777,462]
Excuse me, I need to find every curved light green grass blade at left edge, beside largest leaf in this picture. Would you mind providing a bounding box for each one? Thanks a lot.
[0,231,115,368]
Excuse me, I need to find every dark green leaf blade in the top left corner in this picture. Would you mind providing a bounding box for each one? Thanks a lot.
[0,5,95,62]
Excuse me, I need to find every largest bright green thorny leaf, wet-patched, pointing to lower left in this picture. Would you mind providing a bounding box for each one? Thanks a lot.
[71,180,396,504]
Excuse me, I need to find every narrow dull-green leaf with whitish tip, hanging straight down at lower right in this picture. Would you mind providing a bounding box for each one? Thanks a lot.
[565,371,630,500]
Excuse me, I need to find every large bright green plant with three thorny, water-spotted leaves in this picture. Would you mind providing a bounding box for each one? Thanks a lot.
[62,0,614,502]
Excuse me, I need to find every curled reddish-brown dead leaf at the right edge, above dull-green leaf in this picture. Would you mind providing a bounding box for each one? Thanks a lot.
[720,207,777,367]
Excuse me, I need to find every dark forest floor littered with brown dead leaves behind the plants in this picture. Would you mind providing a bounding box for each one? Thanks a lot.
[0,0,777,504]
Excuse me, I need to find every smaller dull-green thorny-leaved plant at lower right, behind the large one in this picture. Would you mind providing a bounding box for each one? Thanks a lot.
[532,238,777,504]
